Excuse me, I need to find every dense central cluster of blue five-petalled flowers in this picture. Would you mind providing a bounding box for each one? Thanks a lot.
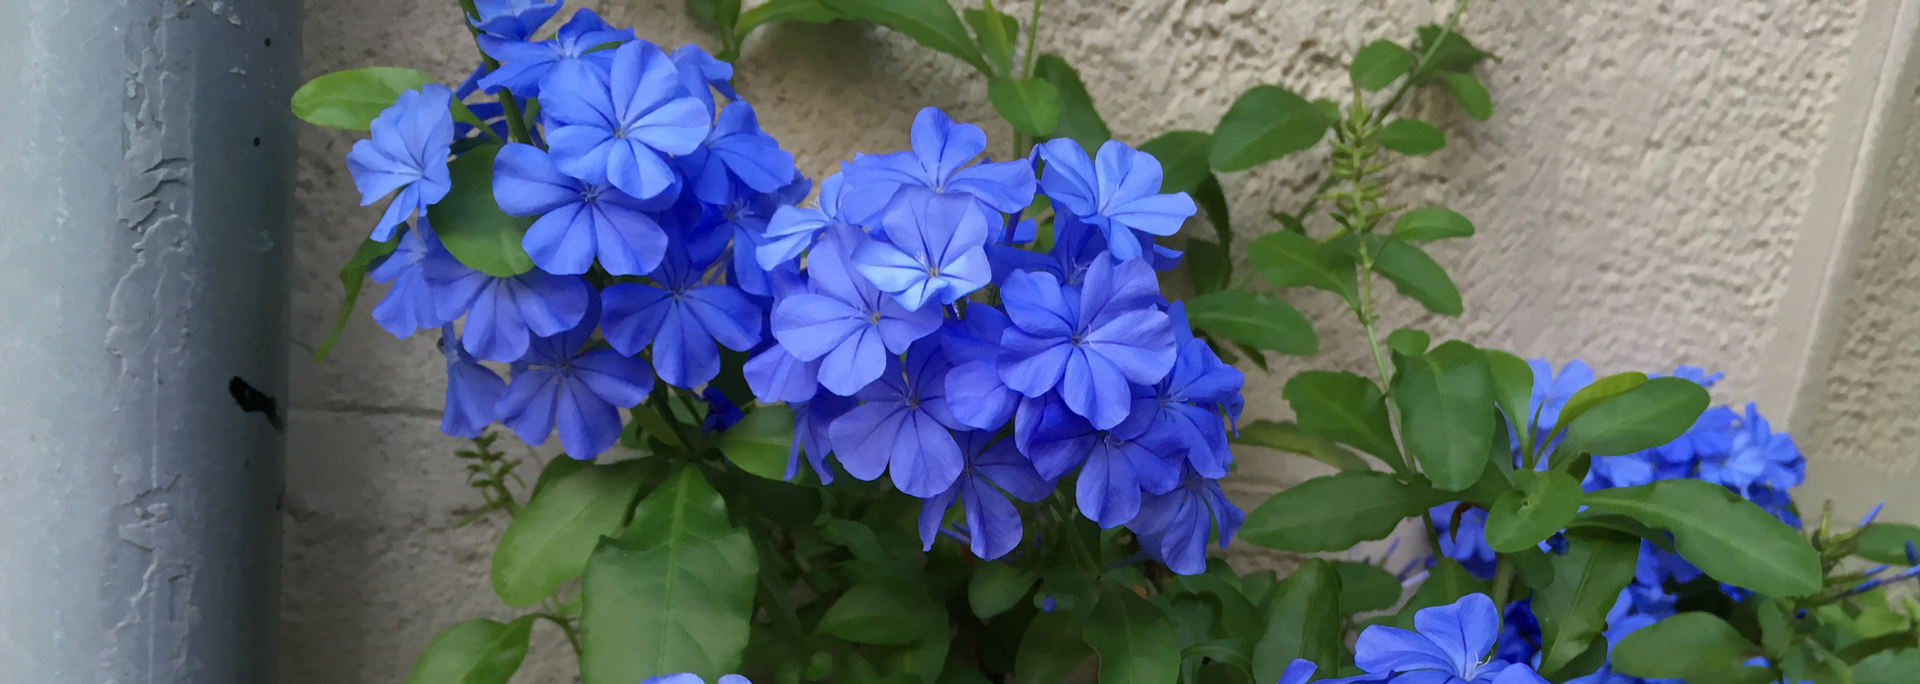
[747,108,1244,573]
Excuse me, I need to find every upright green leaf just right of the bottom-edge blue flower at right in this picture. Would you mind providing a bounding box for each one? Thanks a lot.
[1532,530,1640,672]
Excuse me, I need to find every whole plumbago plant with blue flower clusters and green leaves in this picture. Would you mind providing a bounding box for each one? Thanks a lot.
[294,0,1920,684]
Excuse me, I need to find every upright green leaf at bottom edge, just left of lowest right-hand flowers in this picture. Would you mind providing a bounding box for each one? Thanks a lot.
[1254,559,1346,682]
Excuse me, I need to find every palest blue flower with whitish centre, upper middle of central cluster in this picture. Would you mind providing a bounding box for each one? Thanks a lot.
[852,188,993,309]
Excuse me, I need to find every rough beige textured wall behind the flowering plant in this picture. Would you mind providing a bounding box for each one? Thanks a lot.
[282,0,1862,684]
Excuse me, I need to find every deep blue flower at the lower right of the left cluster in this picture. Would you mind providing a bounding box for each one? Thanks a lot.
[601,229,762,388]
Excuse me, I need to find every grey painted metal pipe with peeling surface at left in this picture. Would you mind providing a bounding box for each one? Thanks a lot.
[0,0,300,684]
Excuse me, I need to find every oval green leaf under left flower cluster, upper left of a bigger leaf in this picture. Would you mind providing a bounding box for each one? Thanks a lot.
[492,461,641,607]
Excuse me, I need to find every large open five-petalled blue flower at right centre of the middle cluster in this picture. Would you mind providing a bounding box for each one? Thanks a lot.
[1000,253,1177,430]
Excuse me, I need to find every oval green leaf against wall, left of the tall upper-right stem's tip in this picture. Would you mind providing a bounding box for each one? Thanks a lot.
[1208,85,1332,171]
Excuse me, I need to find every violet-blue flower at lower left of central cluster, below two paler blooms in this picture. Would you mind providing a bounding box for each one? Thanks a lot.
[829,338,966,498]
